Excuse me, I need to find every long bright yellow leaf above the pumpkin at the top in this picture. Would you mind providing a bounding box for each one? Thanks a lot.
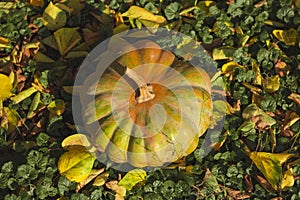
[122,6,166,27]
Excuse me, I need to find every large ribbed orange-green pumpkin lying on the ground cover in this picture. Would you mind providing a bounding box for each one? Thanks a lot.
[83,40,212,167]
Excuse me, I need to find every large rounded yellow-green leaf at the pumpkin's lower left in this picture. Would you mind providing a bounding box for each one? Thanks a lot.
[58,146,96,182]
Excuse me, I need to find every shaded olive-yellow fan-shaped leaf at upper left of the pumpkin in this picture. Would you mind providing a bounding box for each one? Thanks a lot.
[54,28,81,56]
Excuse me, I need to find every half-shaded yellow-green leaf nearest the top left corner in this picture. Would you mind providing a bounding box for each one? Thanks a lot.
[43,1,70,30]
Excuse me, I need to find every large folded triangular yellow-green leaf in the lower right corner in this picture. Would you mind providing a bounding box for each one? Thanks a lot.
[249,152,294,190]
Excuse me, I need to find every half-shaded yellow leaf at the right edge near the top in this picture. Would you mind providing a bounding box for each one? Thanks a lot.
[273,28,298,45]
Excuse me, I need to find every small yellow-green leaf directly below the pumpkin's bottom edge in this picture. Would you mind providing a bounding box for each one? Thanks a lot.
[119,169,147,190]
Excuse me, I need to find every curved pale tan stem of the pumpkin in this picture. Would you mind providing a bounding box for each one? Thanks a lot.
[125,68,155,103]
